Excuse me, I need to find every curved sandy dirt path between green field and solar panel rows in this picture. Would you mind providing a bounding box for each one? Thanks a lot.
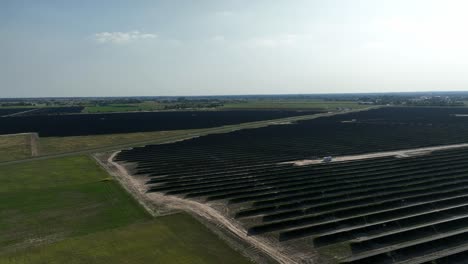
[103,151,300,264]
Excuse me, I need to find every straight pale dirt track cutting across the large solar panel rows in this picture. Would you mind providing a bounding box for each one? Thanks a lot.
[279,143,468,166]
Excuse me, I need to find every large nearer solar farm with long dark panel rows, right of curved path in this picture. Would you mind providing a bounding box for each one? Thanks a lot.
[113,107,468,264]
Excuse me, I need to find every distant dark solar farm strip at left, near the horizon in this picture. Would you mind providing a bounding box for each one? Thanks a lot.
[0,107,321,137]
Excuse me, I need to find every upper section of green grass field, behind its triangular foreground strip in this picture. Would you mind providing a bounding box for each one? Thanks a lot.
[0,156,150,252]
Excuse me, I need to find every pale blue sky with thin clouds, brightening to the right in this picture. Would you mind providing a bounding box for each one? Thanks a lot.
[0,0,468,97]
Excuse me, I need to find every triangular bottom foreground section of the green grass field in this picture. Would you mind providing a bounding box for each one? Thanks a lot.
[0,214,251,264]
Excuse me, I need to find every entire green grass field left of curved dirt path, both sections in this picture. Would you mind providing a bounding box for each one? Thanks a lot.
[0,156,252,263]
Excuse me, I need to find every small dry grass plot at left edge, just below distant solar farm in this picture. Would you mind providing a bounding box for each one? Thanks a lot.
[0,135,31,162]
